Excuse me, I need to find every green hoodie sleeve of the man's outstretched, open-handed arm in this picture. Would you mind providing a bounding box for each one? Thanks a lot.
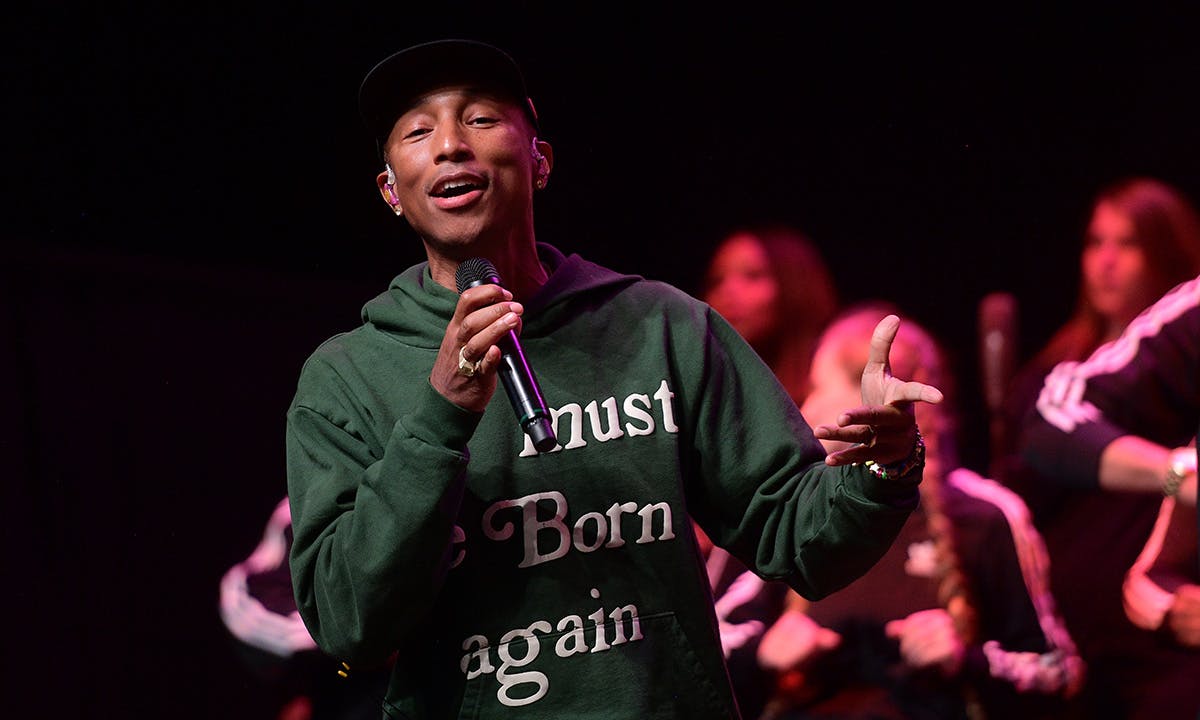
[689,312,920,599]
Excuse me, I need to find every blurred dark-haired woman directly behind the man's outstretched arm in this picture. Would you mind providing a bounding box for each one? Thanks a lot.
[696,223,840,720]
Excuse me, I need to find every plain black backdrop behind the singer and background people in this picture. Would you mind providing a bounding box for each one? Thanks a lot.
[9,1,1200,719]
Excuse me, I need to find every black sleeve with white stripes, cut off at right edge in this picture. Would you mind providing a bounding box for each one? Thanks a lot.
[1020,277,1200,488]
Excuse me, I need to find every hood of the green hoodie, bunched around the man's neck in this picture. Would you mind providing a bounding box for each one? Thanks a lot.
[362,242,642,348]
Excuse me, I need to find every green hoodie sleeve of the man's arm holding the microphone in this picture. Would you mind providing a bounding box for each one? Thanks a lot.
[287,361,480,665]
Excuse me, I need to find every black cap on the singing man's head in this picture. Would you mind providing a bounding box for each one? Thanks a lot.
[359,38,538,154]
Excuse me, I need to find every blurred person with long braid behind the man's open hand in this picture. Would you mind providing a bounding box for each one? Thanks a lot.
[758,302,1085,720]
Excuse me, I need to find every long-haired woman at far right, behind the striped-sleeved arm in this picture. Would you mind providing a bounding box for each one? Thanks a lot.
[995,178,1200,718]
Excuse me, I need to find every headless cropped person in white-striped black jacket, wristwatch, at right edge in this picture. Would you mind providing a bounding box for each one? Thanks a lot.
[1020,271,1200,720]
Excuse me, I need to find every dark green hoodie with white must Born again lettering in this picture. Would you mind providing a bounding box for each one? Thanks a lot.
[287,244,918,720]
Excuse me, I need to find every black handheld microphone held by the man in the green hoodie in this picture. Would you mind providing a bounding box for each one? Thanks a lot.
[455,258,558,452]
